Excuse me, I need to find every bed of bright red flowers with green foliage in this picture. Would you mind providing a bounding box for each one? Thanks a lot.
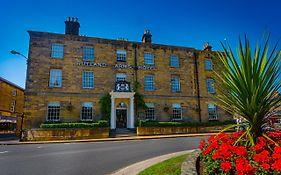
[199,131,281,175]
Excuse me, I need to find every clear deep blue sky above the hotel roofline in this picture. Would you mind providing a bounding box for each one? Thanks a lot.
[0,0,281,87]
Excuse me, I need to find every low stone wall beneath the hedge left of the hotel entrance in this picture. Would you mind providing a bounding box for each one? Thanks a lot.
[23,128,109,141]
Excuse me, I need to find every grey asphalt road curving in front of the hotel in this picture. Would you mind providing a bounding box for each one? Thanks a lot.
[0,137,206,175]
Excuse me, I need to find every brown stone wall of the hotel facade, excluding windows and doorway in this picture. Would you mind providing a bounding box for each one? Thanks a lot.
[25,20,229,128]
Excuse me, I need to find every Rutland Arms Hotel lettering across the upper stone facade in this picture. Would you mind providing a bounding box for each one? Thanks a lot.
[77,61,156,70]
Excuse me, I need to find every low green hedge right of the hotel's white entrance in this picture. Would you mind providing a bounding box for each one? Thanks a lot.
[139,120,235,127]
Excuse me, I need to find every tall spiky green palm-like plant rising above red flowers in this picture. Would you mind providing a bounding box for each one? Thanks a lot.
[215,36,281,145]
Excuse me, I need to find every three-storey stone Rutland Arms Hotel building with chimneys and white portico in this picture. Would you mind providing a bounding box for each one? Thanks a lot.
[24,18,229,129]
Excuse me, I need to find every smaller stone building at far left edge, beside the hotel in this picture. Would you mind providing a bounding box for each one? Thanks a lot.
[0,77,24,133]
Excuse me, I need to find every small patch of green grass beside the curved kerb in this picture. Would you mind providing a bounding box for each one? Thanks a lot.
[138,154,187,175]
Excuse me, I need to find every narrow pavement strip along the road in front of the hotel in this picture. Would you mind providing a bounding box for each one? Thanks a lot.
[0,133,217,145]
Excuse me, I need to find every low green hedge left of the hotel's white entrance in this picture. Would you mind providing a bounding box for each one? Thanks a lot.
[40,120,109,128]
